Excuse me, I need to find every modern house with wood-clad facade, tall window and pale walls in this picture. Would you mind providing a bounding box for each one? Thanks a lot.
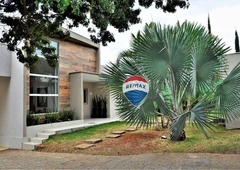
[0,27,117,149]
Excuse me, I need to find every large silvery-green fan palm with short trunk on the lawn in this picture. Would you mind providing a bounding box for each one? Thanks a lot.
[101,21,240,141]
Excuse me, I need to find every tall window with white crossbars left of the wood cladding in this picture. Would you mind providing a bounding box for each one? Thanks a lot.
[29,41,58,114]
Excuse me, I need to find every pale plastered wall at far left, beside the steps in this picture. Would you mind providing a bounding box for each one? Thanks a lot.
[0,47,25,149]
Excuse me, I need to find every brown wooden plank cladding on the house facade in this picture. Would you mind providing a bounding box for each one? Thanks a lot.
[57,40,97,110]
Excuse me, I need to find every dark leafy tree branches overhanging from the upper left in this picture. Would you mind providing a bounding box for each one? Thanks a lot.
[0,0,189,67]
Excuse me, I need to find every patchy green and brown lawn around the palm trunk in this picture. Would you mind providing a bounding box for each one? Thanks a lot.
[34,122,240,155]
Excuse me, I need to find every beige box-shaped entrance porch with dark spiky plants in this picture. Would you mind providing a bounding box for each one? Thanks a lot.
[70,72,108,120]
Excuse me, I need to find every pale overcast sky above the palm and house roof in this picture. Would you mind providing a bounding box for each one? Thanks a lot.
[73,0,240,65]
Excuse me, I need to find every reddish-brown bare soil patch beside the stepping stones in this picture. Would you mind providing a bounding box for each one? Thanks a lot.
[37,131,166,155]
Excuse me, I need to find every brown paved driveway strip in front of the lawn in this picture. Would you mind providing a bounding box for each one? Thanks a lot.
[0,150,240,169]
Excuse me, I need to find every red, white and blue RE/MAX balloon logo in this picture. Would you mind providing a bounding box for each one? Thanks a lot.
[122,75,149,107]
